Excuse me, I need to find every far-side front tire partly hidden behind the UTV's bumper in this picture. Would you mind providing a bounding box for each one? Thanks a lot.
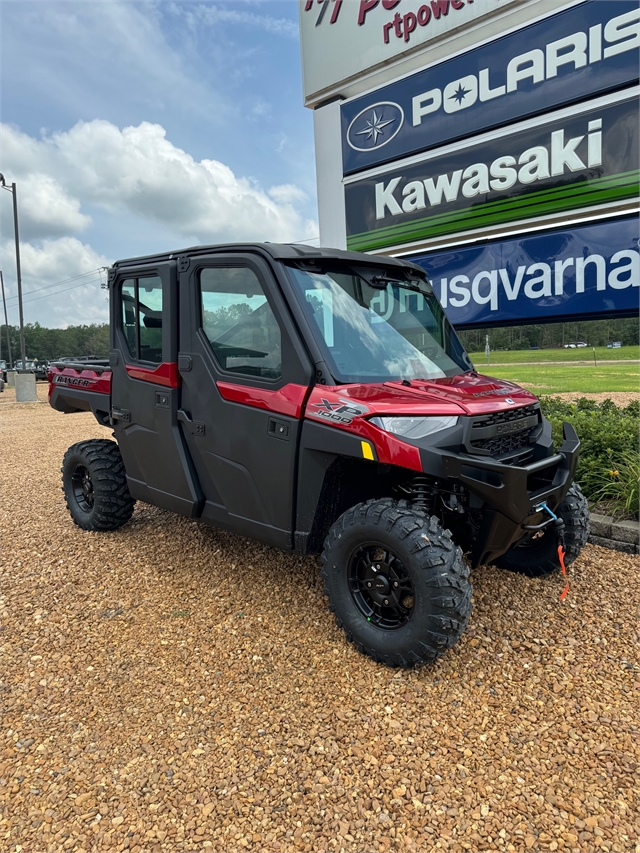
[495,483,589,578]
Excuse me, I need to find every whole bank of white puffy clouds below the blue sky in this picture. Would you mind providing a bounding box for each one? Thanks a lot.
[0,120,317,326]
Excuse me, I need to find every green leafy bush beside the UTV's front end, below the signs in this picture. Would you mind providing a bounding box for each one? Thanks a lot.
[540,397,640,514]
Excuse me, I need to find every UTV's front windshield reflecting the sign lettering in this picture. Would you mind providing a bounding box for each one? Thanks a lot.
[289,267,473,383]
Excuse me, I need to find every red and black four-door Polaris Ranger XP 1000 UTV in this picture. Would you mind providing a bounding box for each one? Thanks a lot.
[49,243,588,666]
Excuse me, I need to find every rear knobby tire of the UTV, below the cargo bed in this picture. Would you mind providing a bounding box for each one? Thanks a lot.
[61,439,135,530]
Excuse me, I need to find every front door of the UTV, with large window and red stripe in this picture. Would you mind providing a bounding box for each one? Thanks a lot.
[179,253,313,549]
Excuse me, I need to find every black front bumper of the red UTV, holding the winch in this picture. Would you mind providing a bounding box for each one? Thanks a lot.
[439,423,580,566]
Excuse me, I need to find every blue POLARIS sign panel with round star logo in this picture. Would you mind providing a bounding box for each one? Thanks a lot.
[341,0,640,174]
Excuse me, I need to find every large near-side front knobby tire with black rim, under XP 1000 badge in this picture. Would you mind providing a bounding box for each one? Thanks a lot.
[322,498,472,667]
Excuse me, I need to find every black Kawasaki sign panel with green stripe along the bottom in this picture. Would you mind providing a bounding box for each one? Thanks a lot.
[345,95,640,251]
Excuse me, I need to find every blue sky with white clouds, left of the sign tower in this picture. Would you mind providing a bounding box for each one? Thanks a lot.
[0,0,318,327]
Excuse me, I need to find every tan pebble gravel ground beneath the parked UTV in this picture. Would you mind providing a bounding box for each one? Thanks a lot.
[0,394,640,853]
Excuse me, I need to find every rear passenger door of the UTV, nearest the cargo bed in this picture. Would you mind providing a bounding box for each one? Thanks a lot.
[109,261,203,516]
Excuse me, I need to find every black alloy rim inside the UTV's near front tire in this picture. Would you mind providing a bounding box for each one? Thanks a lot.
[348,543,414,631]
